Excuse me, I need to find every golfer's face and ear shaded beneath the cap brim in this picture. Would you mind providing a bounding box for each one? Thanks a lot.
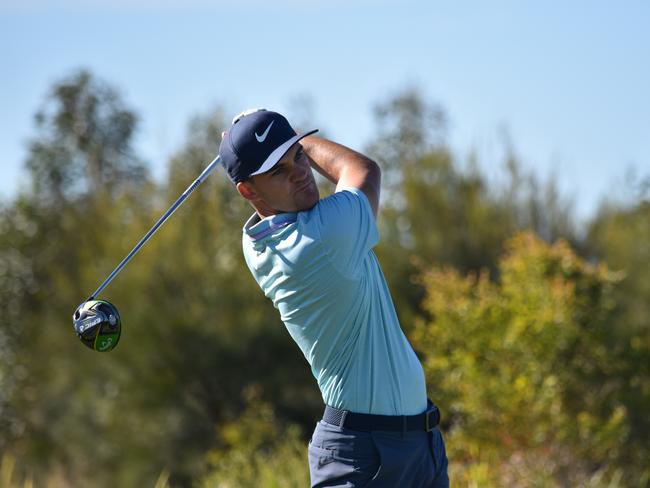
[239,143,319,213]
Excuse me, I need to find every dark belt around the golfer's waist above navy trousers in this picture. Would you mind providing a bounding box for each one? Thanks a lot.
[323,402,440,432]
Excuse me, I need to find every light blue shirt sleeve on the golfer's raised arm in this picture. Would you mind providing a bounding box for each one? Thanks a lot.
[314,188,379,276]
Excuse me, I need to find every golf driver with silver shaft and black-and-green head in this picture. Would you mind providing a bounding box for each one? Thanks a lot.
[72,156,220,352]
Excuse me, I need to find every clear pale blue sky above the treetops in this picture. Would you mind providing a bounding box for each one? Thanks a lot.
[0,0,650,216]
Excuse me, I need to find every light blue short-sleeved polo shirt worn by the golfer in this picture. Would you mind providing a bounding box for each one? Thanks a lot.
[243,188,427,415]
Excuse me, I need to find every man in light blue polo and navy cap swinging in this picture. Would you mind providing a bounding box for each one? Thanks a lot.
[219,109,449,488]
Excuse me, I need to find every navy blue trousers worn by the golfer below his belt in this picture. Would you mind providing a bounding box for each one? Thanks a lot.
[308,420,449,488]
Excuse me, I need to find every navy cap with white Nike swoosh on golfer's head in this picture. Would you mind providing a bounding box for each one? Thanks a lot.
[219,109,318,183]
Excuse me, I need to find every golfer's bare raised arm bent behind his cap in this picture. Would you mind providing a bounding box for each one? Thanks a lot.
[300,136,381,218]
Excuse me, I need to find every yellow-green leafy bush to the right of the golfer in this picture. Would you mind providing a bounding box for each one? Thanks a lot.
[411,233,650,486]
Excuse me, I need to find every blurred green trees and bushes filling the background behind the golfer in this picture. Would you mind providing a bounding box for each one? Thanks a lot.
[0,71,650,487]
